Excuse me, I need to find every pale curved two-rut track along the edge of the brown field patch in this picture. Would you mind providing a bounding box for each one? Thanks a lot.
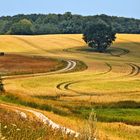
[2,60,77,79]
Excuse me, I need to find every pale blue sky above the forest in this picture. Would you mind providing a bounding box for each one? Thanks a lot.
[0,0,140,19]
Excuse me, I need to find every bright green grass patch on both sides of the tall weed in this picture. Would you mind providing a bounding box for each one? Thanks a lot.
[73,108,140,125]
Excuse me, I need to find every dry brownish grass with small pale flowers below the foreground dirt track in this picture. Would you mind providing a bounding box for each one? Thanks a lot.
[0,107,78,140]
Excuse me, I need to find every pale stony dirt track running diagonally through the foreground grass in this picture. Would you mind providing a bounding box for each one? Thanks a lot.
[0,104,80,137]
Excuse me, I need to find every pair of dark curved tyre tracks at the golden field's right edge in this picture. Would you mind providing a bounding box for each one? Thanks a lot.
[126,63,140,77]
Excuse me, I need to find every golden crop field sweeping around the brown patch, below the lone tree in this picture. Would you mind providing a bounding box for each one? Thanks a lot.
[0,34,140,137]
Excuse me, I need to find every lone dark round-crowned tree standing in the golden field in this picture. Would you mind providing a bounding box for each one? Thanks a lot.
[83,23,116,52]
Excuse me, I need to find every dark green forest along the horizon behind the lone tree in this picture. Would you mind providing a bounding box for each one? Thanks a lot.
[0,12,140,35]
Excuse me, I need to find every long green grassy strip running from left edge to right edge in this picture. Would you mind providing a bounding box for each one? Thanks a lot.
[0,94,140,125]
